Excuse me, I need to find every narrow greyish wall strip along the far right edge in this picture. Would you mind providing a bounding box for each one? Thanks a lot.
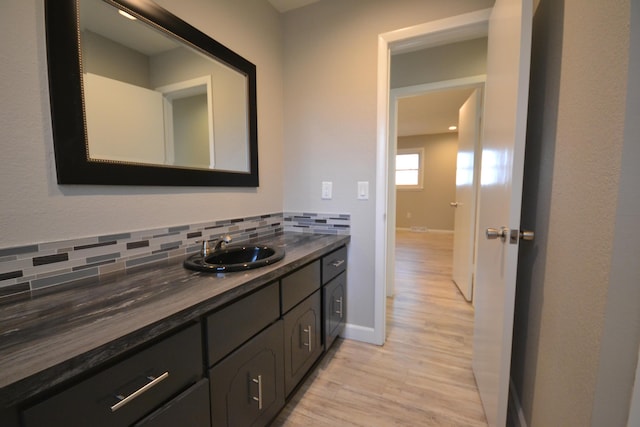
[591,1,640,427]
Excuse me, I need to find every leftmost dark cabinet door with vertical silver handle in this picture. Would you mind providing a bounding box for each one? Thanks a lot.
[209,320,284,427]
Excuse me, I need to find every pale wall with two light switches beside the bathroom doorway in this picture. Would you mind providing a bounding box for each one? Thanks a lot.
[284,0,493,331]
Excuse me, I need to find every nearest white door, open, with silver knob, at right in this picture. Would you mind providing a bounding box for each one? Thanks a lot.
[473,0,533,426]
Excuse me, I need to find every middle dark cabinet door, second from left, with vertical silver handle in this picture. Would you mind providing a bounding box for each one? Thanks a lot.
[284,291,324,395]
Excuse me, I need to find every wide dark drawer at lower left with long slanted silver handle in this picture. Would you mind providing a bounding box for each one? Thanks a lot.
[23,324,202,427]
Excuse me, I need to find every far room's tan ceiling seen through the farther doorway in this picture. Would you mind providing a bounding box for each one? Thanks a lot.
[397,88,474,136]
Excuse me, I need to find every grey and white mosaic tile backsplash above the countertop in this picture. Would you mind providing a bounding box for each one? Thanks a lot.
[0,213,350,300]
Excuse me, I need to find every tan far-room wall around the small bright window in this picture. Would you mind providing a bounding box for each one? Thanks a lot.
[396,133,458,231]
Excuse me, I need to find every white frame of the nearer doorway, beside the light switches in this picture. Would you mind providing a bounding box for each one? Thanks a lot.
[371,8,491,345]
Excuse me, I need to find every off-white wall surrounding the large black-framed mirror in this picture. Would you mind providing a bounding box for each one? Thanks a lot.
[0,0,283,247]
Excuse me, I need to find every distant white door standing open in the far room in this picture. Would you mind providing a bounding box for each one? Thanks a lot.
[451,89,482,301]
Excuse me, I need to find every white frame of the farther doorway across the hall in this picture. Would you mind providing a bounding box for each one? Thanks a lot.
[386,74,487,297]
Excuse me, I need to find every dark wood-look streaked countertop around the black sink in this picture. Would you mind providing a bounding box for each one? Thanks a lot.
[0,233,349,409]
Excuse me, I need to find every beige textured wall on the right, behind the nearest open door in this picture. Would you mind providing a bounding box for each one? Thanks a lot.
[511,0,640,427]
